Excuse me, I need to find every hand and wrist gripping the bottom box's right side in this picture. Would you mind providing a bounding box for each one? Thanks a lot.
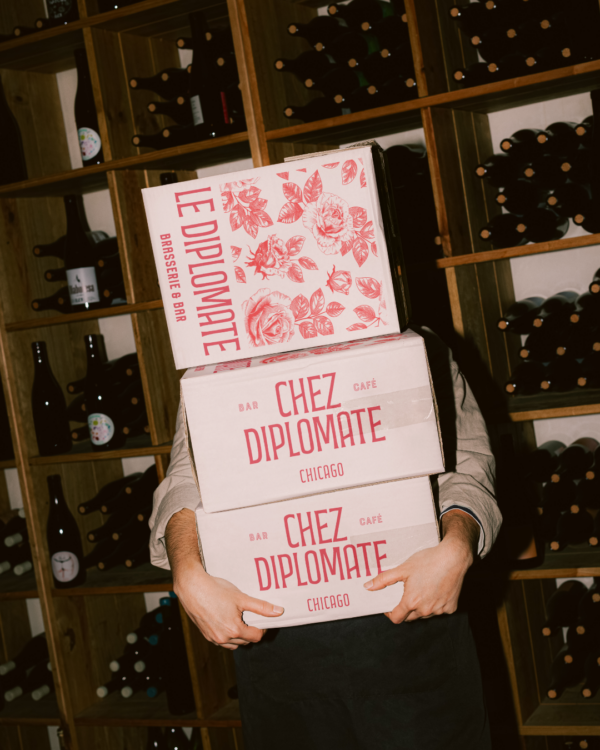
[365,510,480,624]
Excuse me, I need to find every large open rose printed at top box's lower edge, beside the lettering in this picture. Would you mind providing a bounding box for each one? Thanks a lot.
[242,289,294,346]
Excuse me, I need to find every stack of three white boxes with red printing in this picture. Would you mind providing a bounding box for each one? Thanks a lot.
[144,143,443,627]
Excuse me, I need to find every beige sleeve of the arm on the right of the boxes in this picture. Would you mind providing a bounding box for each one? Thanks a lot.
[415,328,502,557]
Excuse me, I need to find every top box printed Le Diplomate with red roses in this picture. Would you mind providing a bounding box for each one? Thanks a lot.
[142,144,409,369]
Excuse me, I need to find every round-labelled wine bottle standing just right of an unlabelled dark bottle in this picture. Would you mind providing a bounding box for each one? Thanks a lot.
[84,334,125,451]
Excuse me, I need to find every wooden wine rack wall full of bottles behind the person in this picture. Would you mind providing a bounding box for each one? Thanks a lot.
[0,0,600,750]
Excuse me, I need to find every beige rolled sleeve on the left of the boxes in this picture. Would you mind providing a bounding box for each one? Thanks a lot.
[149,403,200,570]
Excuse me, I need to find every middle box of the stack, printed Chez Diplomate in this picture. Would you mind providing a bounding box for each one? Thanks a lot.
[181,331,444,513]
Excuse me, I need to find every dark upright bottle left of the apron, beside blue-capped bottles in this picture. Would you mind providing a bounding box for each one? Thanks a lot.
[160,599,195,716]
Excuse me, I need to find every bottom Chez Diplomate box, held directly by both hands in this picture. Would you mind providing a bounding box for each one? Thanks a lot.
[196,477,439,628]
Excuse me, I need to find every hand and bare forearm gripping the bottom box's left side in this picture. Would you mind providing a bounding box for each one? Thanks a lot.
[165,509,283,650]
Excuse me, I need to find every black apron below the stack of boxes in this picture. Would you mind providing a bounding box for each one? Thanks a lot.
[234,612,491,750]
